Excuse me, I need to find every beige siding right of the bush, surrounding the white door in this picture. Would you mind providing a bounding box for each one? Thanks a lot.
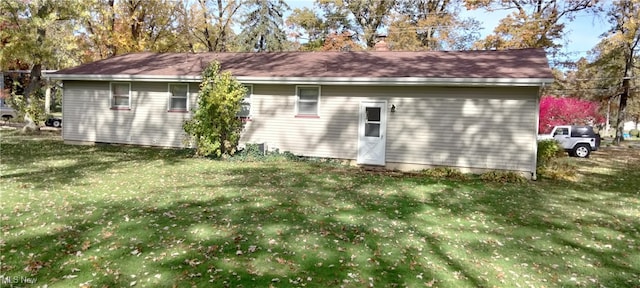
[242,85,538,171]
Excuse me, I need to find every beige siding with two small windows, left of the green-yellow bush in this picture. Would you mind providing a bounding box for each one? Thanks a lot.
[63,81,198,147]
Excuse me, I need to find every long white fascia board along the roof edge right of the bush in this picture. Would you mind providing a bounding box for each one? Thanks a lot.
[236,76,553,87]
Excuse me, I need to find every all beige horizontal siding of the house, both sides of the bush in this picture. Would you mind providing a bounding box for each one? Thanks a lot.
[63,81,538,171]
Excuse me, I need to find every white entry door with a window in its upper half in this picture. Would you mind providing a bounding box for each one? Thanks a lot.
[357,101,387,165]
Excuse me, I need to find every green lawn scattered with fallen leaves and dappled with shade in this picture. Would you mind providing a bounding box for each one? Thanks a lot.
[0,131,640,287]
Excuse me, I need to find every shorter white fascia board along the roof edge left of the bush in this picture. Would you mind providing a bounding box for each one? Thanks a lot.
[43,74,202,82]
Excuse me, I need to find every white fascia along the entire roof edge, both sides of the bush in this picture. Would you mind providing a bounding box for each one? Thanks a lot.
[45,74,553,87]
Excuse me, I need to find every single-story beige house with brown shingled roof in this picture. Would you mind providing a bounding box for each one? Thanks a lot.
[47,49,553,177]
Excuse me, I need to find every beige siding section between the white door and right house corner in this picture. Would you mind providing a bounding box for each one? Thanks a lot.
[386,97,536,171]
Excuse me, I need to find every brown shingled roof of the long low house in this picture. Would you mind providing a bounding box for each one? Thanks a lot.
[52,49,553,78]
